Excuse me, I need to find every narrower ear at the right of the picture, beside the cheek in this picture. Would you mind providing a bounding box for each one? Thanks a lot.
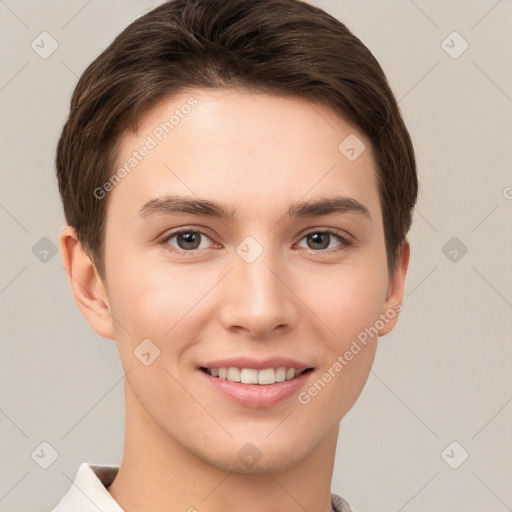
[379,239,411,336]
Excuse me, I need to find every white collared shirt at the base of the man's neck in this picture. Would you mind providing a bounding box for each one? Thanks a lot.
[51,462,353,512]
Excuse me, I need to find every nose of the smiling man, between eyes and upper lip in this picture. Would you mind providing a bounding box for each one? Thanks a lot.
[220,242,300,339]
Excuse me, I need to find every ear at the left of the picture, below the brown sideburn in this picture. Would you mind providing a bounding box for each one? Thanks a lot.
[59,226,115,340]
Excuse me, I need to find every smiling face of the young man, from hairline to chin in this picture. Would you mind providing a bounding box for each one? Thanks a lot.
[76,89,403,472]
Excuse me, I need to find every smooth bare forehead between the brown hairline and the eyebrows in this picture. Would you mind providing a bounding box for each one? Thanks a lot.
[110,89,378,222]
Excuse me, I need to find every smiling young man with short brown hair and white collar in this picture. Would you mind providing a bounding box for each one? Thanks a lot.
[54,0,418,512]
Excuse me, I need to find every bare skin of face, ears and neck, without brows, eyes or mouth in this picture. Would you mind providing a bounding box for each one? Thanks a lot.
[60,89,409,512]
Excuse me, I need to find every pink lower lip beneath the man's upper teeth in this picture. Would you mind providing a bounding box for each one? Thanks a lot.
[198,370,313,409]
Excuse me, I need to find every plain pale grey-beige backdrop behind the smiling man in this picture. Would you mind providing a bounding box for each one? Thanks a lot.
[0,0,512,512]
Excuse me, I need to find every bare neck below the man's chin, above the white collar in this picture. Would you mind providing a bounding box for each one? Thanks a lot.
[108,382,339,512]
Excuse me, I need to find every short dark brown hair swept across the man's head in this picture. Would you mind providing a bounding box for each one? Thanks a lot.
[55,0,418,279]
